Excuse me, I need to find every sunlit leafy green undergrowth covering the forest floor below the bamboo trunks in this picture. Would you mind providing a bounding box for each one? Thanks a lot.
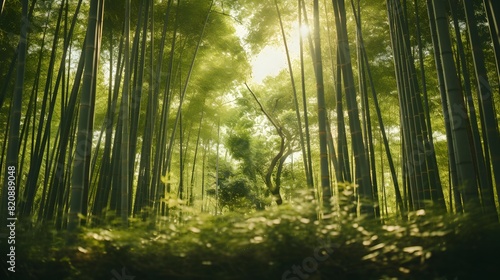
[0,203,500,280]
